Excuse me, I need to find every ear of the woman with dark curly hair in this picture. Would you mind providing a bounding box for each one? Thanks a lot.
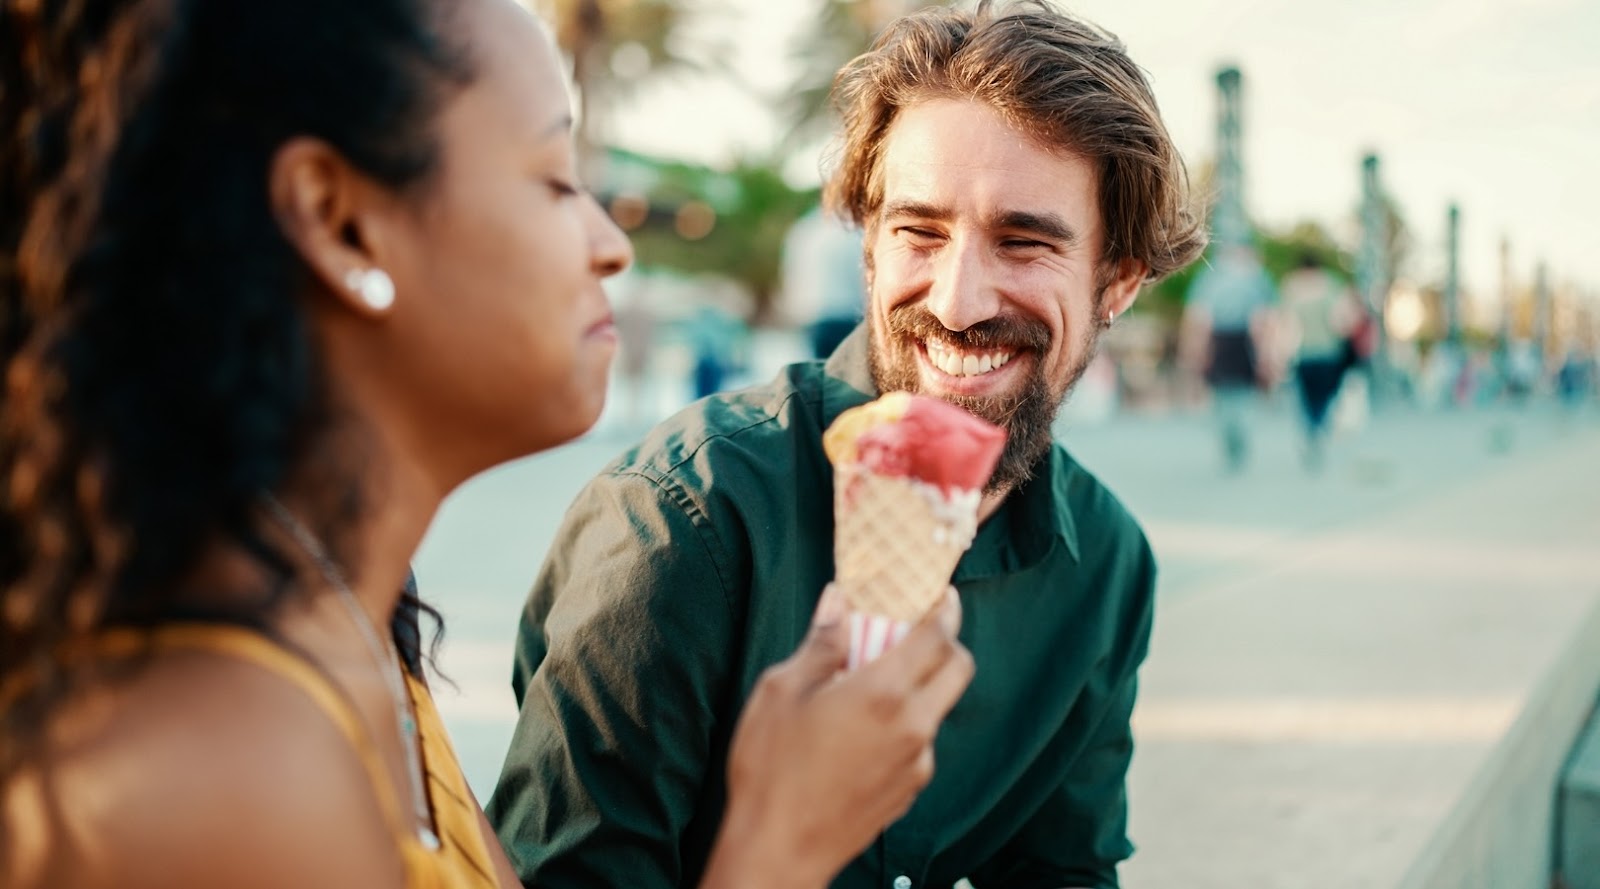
[267,136,387,317]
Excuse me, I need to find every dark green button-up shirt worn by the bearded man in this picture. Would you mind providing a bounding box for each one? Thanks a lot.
[488,329,1155,889]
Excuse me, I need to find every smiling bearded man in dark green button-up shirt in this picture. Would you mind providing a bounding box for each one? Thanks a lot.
[490,3,1205,889]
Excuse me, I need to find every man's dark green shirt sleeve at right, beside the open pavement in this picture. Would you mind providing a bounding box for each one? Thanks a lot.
[971,536,1155,889]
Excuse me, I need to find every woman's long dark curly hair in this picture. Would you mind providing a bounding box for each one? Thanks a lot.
[0,0,472,783]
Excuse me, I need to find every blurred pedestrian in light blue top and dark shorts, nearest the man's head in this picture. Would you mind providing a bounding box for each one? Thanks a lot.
[1184,245,1275,472]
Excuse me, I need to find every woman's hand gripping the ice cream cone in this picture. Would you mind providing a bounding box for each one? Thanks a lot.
[702,588,973,889]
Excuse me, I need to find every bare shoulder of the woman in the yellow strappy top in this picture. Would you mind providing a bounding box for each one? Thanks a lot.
[0,652,403,889]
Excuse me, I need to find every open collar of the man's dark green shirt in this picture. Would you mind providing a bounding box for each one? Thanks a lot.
[822,323,1078,580]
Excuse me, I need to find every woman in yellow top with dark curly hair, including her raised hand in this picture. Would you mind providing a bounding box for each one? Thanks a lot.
[0,0,971,889]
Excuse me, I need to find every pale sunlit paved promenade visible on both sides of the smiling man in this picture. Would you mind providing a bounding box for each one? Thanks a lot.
[418,380,1600,889]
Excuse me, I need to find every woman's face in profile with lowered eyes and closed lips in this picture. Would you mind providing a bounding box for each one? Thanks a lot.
[374,0,632,475]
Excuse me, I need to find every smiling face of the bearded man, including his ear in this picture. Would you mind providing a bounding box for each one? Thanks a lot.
[867,99,1144,491]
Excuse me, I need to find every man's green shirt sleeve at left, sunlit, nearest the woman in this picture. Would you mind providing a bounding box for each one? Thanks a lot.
[488,473,733,889]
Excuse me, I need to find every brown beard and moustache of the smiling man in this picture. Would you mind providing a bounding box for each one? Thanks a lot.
[867,299,1099,494]
